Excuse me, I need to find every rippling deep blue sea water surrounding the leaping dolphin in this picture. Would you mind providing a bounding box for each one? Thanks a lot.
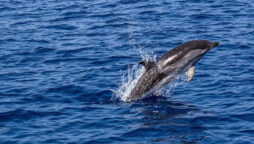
[0,0,254,144]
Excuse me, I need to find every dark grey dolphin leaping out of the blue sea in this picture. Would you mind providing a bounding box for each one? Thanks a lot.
[127,40,219,101]
